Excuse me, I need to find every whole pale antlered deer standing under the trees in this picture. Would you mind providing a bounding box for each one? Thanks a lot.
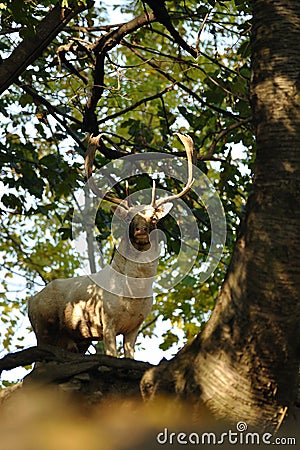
[28,133,195,359]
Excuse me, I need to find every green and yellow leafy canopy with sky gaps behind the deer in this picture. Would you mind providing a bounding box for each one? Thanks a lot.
[0,0,254,362]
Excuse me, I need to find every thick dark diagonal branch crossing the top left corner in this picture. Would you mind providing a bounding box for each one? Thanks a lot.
[0,2,91,94]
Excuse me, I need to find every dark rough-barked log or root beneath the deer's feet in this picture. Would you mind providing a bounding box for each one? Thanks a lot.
[0,345,152,404]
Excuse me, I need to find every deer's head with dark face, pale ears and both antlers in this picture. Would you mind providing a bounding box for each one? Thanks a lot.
[85,133,195,250]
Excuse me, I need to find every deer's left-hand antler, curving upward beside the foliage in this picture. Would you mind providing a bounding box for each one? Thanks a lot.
[84,134,129,209]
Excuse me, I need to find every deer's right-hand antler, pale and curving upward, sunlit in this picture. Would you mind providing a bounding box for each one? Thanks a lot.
[151,133,195,208]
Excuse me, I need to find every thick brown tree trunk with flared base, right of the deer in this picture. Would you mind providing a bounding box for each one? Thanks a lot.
[142,0,300,430]
